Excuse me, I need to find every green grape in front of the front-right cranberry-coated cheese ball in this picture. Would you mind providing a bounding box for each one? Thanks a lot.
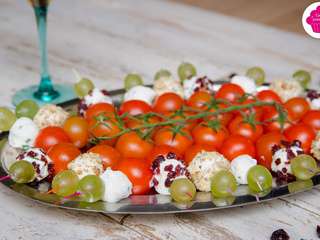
[291,154,318,180]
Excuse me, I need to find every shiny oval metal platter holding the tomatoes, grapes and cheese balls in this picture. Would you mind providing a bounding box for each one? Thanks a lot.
[0,82,320,214]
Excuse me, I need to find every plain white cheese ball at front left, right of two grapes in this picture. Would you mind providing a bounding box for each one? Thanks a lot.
[100,168,132,203]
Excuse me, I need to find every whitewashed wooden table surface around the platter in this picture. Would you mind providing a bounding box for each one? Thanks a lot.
[0,0,320,240]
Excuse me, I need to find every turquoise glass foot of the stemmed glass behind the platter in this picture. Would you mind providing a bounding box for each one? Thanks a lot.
[12,84,76,106]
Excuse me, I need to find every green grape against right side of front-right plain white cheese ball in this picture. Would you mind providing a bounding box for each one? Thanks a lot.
[247,165,272,193]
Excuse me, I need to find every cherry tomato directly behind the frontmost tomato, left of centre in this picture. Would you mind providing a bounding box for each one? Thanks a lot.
[116,132,153,159]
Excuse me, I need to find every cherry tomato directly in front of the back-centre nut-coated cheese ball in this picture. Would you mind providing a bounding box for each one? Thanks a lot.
[153,92,184,113]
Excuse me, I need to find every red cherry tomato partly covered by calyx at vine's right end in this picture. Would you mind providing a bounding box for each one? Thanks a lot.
[263,107,291,132]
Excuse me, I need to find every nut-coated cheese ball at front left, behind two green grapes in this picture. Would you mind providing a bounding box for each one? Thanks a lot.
[68,153,103,179]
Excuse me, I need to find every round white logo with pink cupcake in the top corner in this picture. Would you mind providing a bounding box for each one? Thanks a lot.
[302,2,320,38]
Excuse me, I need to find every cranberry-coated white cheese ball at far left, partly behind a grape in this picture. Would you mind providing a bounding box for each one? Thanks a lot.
[16,148,54,181]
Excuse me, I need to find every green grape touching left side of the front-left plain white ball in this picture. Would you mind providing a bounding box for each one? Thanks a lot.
[79,175,104,202]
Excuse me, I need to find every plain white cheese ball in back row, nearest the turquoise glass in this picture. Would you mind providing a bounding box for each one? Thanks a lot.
[124,86,157,105]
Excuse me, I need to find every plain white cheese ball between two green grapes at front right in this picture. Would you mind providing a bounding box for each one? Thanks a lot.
[231,154,257,184]
